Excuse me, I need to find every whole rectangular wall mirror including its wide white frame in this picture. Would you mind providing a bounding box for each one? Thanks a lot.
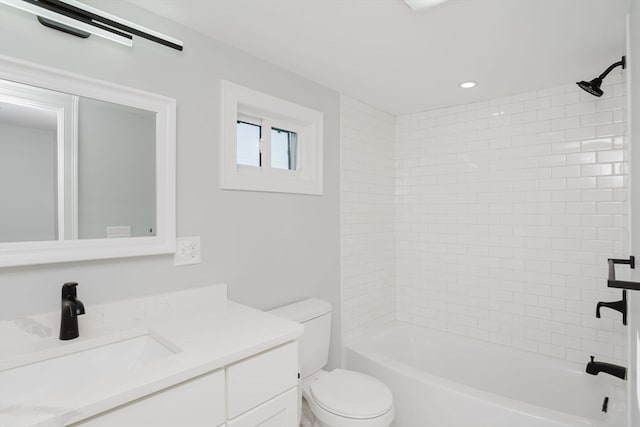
[0,56,176,266]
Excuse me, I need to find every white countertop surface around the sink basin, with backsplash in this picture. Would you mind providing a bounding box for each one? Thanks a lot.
[0,285,303,427]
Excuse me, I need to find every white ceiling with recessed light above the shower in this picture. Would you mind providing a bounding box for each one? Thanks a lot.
[130,0,630,115]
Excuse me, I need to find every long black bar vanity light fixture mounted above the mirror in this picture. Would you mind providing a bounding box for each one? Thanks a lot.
[0,0,183,50]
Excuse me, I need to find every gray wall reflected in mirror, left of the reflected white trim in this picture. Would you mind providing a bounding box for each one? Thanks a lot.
[0,123,58,244]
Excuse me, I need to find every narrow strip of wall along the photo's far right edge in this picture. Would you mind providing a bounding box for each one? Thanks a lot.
[627,1,640,426]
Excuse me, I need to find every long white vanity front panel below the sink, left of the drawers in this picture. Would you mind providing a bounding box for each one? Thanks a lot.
[73,370,226,427]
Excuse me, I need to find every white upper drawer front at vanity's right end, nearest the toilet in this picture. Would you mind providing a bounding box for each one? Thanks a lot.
[227,342,298,419]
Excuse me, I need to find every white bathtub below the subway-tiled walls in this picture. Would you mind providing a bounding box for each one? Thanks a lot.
[344,322,626,427]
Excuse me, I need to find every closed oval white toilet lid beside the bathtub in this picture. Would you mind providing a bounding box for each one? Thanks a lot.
[310,369,393,418]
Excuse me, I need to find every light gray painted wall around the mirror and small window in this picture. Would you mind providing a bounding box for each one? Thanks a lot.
[0,1,340,366]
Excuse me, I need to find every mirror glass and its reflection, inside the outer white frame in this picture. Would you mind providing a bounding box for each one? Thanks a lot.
[0,80,157,243]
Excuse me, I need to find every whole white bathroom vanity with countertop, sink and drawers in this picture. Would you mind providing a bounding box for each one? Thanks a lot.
[0,284,303,427]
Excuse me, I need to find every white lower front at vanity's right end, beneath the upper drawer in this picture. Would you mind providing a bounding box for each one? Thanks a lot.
[227,388,298,427]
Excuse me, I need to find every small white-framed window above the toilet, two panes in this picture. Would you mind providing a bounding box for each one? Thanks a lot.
[221,81,323,194]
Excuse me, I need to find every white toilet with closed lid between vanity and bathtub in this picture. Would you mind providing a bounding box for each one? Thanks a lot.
[271,298,395,427]
